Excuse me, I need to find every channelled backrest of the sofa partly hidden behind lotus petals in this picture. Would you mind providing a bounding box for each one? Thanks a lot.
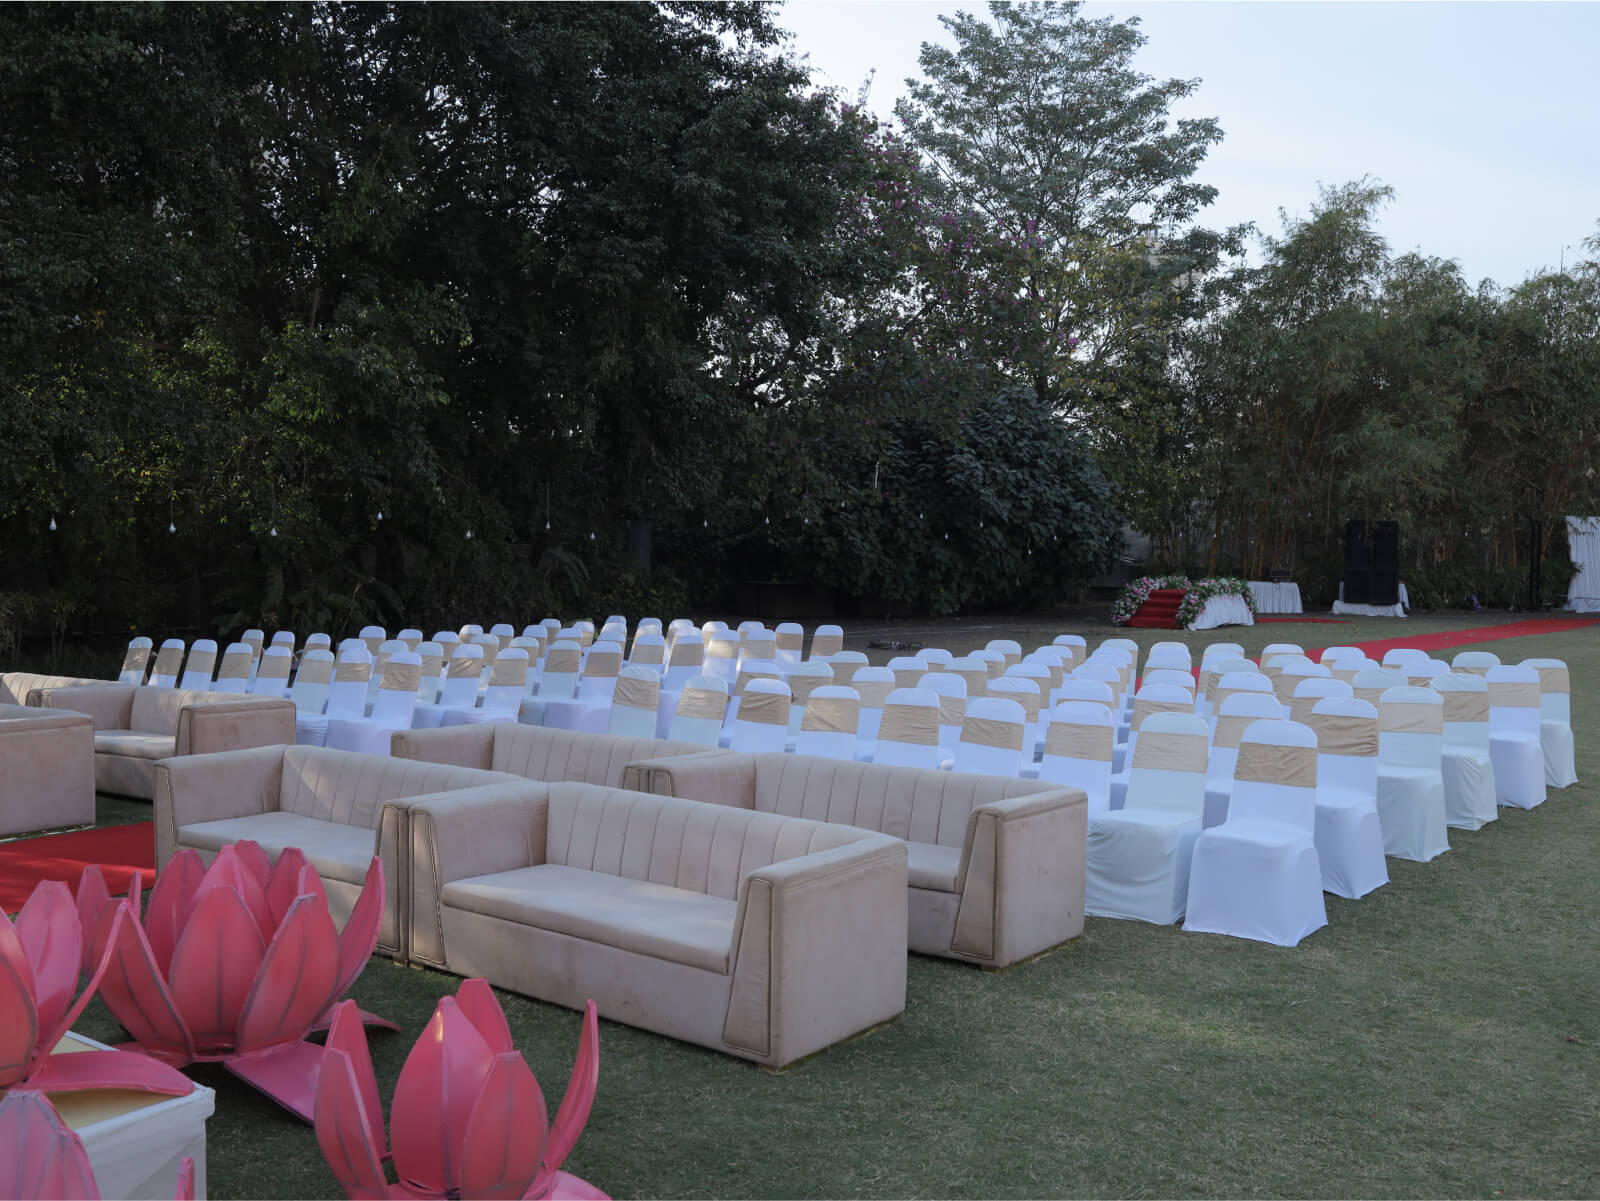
[278,747,518,830]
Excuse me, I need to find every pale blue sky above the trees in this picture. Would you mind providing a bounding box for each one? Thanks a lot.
[778,0,1600,286]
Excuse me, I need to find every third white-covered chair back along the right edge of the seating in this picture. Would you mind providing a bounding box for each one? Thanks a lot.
[1355,690,1450,864]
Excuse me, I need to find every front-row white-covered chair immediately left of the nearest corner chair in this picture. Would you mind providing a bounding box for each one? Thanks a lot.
[1083,713,1206,926]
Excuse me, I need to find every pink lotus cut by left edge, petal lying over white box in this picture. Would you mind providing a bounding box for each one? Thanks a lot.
[0,880,194,1106]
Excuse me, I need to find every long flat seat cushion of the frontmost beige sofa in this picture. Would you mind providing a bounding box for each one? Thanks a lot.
[441,863,738,974]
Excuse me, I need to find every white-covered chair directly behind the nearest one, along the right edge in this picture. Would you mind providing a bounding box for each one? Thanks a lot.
[1301,694,1389,900]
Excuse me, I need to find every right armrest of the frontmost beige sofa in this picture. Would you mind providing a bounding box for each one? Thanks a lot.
[722,835,907,1067]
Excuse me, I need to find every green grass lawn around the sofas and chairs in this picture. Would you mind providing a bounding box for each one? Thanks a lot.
[31,617,1600,1198]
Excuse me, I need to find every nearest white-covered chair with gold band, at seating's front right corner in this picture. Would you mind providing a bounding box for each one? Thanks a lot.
[1184,721,1328,947]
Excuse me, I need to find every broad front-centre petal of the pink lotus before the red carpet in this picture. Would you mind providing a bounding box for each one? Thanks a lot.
[166,888,267,1054]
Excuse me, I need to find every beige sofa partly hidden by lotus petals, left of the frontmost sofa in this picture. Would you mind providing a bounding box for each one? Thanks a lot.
[155,747,538,958]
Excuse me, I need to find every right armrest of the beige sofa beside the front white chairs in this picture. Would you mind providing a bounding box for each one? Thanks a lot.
[950,788,1088,968]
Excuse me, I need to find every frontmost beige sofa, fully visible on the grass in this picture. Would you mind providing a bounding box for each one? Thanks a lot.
[411,784,906,1067]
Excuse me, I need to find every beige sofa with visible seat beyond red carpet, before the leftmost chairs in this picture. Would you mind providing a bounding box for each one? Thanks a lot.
[34,684,294,800]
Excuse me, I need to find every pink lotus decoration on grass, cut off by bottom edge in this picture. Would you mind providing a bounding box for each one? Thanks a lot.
[317,979,605,1201]
